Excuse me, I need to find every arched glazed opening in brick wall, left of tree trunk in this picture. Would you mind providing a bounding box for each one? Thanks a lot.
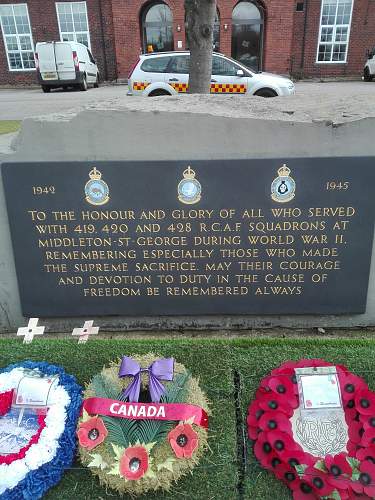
[141,2,173,52]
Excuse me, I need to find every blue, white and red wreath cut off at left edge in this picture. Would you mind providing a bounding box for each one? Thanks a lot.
[0,361,82,500]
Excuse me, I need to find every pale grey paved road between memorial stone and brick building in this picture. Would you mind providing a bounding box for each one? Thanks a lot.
[0,81,375,120]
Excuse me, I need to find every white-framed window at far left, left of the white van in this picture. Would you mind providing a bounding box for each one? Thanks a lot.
[0,4,35,71]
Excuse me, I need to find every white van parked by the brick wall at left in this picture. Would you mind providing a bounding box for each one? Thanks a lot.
[35,42,99,92]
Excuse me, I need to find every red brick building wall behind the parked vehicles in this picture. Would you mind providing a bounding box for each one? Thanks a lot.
[0,0,375,85]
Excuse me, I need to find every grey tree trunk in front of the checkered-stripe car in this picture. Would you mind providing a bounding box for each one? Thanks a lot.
[185,0,216,94]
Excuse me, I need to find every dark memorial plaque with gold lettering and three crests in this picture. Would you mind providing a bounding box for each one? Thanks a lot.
[2,158,375,317]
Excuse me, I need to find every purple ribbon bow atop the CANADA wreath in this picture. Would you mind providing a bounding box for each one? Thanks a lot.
[119,356,174,403]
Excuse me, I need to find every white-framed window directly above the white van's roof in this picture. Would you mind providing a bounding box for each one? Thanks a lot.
[56,2,90,48]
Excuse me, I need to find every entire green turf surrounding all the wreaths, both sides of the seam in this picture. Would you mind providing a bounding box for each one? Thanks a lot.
[0,338,375,500]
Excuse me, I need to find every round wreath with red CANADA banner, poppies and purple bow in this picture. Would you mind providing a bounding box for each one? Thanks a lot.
[77,354,208,496]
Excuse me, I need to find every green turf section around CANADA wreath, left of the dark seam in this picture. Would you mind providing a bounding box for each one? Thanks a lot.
[0,339,238,500]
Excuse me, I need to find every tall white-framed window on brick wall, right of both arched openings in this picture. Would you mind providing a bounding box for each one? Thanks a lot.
[317,0,353,63]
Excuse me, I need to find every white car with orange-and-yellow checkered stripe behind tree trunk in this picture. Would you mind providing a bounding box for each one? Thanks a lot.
[128,51,295,97]
